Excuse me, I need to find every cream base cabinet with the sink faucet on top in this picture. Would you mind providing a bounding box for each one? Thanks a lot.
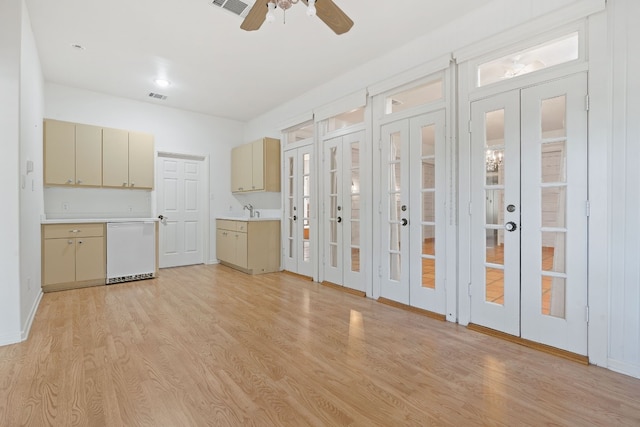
[216,219,280,274]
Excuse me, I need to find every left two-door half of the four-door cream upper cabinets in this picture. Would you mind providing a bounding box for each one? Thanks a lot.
[44,120,102,187]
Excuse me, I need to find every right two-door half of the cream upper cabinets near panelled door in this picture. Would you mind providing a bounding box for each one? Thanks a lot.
[102,129,154,189]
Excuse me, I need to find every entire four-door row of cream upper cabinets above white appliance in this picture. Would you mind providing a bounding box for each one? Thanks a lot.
[44,119,154,189]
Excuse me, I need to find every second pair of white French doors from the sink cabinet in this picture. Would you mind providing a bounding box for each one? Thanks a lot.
[323,131,365,292]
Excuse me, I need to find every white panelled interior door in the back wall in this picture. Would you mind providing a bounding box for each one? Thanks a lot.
[157,156,205,268]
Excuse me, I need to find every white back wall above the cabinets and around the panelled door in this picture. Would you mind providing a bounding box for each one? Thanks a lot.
[44,83,243,261]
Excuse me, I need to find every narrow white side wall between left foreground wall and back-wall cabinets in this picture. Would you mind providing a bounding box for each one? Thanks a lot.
[19,1,44,340]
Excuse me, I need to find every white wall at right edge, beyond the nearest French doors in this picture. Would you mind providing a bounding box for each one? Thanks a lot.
[603,0,640,377]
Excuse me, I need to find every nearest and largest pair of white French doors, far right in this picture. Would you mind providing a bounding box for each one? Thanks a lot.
[470,73,588,355]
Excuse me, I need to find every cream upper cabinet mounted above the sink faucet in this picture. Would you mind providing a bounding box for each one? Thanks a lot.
[231,138,280,193]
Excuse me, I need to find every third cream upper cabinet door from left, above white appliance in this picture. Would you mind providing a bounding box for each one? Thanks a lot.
[102,129,129,188]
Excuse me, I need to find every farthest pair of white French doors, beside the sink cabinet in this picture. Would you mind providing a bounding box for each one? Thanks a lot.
[282,144,314,277]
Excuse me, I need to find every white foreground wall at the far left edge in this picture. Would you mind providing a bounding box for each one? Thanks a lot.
[0,0,22,345]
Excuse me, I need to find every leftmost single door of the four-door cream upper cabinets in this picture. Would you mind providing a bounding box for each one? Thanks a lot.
[44,120,76,185]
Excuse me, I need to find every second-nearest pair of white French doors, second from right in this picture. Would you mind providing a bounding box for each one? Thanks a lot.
[380,111,446,314]
